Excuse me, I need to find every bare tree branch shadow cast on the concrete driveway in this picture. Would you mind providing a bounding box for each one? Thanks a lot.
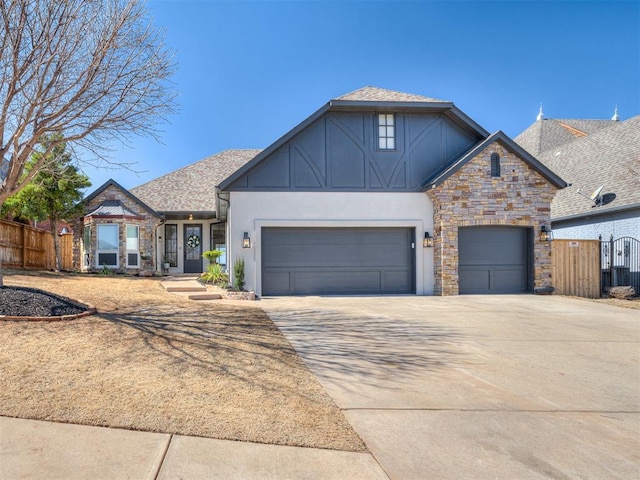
[267,308,465,383]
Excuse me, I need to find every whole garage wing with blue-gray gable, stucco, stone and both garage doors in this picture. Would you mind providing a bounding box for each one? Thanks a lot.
[219,87,566,295]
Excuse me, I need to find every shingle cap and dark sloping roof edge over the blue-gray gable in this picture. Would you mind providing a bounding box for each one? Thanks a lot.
[219,86,489,190]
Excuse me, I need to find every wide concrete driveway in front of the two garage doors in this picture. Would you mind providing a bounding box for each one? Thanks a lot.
[261,295,640,479]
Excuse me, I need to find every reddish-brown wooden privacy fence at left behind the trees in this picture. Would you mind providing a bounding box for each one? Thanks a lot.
[0,220,73,270]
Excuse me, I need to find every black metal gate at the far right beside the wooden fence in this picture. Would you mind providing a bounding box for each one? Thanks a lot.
[600,235,640,295]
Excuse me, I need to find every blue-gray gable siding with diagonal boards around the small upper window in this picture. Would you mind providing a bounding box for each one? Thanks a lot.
[228,111,482,191]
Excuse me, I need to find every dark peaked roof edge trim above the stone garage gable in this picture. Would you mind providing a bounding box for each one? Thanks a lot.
[424,131,567,190]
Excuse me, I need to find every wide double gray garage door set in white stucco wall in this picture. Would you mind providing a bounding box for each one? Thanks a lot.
[262,228,415,295]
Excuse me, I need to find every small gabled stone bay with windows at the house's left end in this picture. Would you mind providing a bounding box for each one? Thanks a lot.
[73,180,162,273]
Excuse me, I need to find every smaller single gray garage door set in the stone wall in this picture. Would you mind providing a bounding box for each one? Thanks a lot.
[458,227,531,294]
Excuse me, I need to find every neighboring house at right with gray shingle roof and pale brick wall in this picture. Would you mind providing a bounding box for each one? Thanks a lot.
[515,112,640,240]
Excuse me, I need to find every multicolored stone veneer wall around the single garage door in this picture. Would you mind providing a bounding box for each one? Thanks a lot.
[427,142,557,295]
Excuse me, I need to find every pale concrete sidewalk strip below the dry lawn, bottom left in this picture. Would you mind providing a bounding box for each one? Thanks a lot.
[0,417,388,480]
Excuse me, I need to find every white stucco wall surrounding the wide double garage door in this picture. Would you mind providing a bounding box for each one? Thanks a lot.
[227,192,434,295]
